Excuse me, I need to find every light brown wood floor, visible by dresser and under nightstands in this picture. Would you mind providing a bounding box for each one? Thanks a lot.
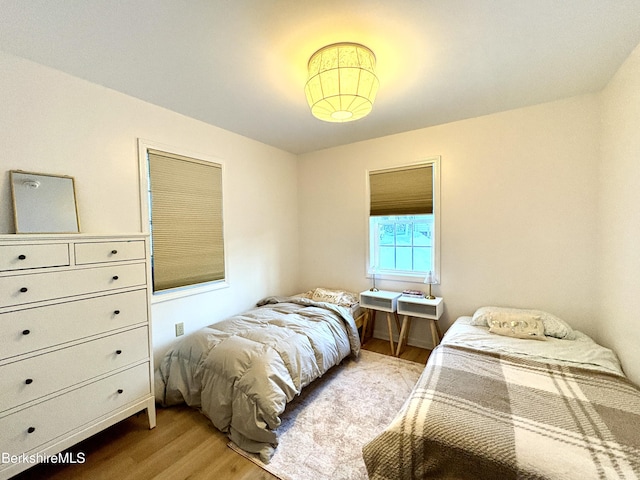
[14,338,430,480]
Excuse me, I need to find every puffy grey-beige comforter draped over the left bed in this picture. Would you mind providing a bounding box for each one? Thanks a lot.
[156,297,360,462]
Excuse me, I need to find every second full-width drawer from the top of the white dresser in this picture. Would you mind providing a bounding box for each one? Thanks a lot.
[0,289,147,359]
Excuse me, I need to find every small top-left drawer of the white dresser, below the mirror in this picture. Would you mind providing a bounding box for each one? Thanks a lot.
[0,243,69,271]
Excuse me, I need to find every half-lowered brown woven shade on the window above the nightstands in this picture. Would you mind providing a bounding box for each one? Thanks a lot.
[369,165,433,216]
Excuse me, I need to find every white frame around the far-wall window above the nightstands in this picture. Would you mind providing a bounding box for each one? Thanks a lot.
[365,156,441,284]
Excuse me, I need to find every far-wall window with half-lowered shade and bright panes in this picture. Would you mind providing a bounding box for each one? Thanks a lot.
[368,158,440,280]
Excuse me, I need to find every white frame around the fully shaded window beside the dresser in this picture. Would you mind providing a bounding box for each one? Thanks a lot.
[138,138,229,304]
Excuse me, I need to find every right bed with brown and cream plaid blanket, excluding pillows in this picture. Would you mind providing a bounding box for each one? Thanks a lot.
[363,320,640,480]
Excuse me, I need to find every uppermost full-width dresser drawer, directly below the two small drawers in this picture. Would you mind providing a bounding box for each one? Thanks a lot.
[0,263,147,306]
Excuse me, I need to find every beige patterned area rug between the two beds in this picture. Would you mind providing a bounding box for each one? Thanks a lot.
[229,350,424,480]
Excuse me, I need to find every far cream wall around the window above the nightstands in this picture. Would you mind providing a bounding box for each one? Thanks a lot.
[299,95,600,346]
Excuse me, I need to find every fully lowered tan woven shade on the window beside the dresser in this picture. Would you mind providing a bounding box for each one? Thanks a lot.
[149,150,225,291]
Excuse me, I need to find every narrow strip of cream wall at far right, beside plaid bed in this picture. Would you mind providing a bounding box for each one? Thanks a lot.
[598,45,640,384]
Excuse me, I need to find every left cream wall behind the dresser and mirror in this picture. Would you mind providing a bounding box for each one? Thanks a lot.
[0,53,298,358]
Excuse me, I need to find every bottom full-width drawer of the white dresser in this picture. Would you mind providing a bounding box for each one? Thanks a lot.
[0,363,151,458]
